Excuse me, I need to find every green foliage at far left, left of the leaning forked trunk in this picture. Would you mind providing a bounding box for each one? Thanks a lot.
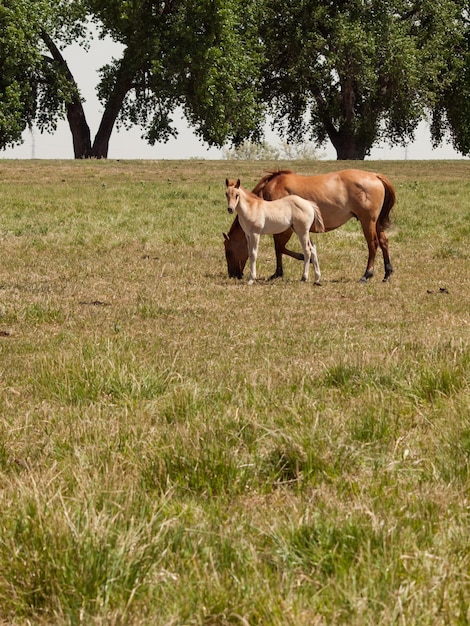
[0,0,86,147]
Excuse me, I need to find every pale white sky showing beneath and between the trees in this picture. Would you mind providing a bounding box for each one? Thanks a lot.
[0,33,462,160]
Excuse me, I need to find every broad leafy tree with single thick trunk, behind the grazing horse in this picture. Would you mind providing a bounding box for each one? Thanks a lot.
[261,0,460,159]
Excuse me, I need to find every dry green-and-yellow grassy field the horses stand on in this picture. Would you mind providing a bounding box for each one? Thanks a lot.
[0,160,470,626]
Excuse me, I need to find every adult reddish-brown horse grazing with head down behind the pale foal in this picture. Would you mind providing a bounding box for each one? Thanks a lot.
[224,170,396,282]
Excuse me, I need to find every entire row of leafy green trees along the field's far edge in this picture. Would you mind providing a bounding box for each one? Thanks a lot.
[0,0,470,159]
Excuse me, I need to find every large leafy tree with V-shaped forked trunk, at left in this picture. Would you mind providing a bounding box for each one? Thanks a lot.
[0,0,264,158]
